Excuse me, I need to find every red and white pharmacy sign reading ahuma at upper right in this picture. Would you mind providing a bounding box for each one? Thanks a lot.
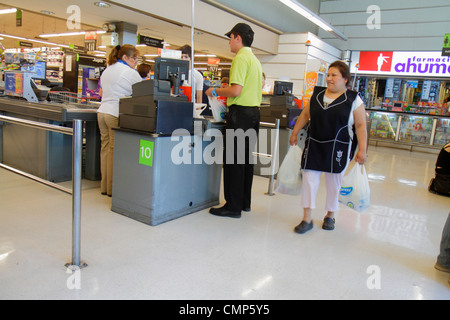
[351,51,450,78]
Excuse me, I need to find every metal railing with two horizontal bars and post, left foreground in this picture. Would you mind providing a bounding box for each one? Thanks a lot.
[0,115,87,268]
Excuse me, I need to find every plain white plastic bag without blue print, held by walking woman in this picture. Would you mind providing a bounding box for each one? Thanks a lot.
[275,145,302,196]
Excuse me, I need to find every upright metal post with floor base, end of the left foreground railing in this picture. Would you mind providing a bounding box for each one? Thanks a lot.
[66,120,87,268]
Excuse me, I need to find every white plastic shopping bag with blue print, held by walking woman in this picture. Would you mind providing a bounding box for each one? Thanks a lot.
[339,163,370,212]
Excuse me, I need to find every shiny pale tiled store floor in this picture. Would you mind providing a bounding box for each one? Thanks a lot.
[0,146,450,300]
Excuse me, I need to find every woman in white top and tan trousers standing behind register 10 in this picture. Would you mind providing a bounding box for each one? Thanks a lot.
[97,44,142,196]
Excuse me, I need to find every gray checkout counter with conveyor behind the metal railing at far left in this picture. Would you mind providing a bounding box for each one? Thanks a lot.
[0,72,100,183]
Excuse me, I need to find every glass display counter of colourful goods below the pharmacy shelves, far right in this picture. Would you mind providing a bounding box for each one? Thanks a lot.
[367,109,450,150]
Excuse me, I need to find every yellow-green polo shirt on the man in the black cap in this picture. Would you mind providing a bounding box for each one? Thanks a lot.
[227,47,262,107]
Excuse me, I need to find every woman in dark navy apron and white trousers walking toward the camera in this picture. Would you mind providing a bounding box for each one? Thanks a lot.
[290,61,367,233]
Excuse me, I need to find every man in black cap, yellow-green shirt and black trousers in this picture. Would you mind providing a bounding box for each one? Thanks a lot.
[206,23,262,218]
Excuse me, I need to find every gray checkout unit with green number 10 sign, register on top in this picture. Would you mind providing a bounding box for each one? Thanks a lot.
[111,70,222,226]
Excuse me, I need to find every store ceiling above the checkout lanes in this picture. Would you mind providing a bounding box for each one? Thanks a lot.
[0,0,320,68]
